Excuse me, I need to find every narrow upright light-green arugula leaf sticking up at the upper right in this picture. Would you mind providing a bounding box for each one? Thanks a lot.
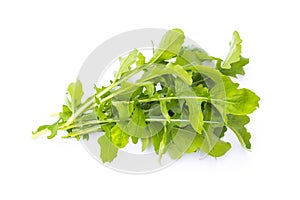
[221,31,242,69]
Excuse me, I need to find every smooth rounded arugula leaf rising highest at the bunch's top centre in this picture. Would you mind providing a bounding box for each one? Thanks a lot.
[149,29,184,63]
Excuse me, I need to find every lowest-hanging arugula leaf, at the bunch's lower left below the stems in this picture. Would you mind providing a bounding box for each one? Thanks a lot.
[98,134,118,163]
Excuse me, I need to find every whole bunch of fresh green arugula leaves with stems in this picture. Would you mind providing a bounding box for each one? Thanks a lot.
[33,29,259,162]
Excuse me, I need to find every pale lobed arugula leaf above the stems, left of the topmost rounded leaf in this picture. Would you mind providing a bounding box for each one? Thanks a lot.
[115,49,141,79]
